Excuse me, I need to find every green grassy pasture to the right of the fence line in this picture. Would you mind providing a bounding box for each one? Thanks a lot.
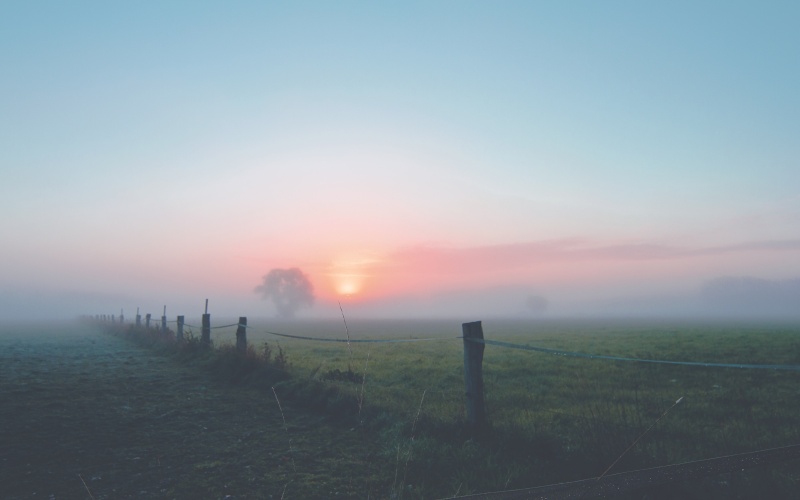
[106,318,800,498]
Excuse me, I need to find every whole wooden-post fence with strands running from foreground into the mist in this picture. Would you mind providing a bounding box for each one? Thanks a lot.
[83,301,800,499]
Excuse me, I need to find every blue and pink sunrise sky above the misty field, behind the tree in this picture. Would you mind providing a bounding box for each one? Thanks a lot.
[0,0,800,320]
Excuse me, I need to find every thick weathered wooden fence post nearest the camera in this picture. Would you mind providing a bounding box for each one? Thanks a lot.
[461,321,488,432]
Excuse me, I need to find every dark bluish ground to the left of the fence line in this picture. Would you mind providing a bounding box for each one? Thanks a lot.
[0,326,393,500]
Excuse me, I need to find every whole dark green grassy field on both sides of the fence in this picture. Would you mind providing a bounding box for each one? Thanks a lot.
[0,318,800,498]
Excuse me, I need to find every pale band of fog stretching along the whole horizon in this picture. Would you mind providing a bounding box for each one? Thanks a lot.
[0,276,800,322]
